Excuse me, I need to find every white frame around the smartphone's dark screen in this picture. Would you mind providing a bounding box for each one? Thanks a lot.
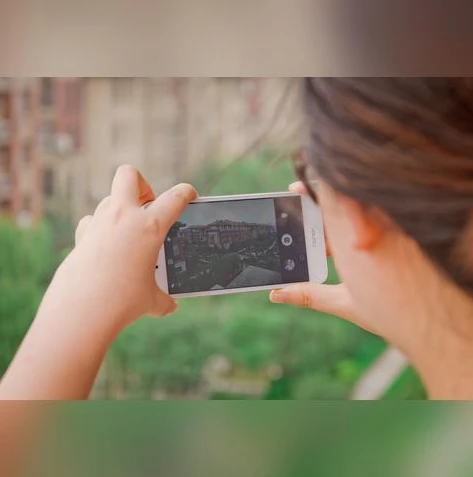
[155,192,328,298]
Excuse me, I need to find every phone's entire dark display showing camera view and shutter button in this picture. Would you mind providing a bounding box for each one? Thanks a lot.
[164,197,309,294]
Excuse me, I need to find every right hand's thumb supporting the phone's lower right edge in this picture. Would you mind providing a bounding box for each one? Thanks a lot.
[270,283,355,321]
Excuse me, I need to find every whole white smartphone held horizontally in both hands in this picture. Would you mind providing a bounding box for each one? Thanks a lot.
[156,192,327,297]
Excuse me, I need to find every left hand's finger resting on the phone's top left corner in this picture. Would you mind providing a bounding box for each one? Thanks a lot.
[146,184,197,231]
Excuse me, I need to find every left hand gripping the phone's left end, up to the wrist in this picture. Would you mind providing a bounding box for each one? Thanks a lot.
[45,166,197,329]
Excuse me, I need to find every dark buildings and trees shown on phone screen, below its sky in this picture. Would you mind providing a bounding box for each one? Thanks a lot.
[166,210,281,293]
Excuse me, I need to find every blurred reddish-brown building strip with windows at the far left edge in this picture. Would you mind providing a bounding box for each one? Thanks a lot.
[0,78,43,227]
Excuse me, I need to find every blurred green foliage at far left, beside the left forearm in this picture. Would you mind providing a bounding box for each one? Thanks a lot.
[0,219,53,375]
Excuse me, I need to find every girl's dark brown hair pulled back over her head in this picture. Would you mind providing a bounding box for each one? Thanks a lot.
[304,78,473,295]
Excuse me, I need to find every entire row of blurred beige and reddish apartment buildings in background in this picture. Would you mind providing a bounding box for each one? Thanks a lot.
[0,78,302,229]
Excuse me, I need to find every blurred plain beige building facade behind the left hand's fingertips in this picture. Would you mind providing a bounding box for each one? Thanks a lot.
[81,78,302,218]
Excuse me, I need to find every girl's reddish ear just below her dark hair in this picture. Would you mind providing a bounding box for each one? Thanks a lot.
[339,197,384,251]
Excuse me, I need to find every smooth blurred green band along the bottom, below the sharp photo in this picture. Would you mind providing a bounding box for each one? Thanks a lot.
[29,401,460,477]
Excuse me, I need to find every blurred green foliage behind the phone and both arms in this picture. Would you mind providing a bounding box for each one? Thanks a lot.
[0,149,425,400]
